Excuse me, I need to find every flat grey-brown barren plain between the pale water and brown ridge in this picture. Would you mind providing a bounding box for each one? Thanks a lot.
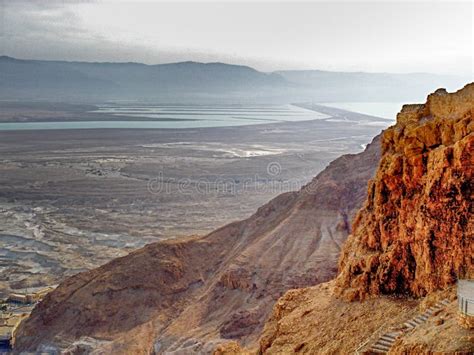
[0,103,390,293]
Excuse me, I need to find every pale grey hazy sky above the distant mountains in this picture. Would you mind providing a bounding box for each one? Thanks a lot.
[0,0,474,75]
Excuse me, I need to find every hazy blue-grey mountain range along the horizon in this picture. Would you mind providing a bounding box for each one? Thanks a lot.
[0,56,467,103]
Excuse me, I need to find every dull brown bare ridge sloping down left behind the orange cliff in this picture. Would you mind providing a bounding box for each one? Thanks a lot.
[13,134,380,354]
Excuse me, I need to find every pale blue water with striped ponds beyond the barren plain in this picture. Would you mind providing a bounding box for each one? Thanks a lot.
[0,105,329,130]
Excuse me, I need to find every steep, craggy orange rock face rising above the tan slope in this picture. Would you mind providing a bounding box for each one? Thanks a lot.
[336,84,474,300]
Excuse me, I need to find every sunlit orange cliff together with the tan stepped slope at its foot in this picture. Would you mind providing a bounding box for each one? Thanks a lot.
[260,84,474,354]
